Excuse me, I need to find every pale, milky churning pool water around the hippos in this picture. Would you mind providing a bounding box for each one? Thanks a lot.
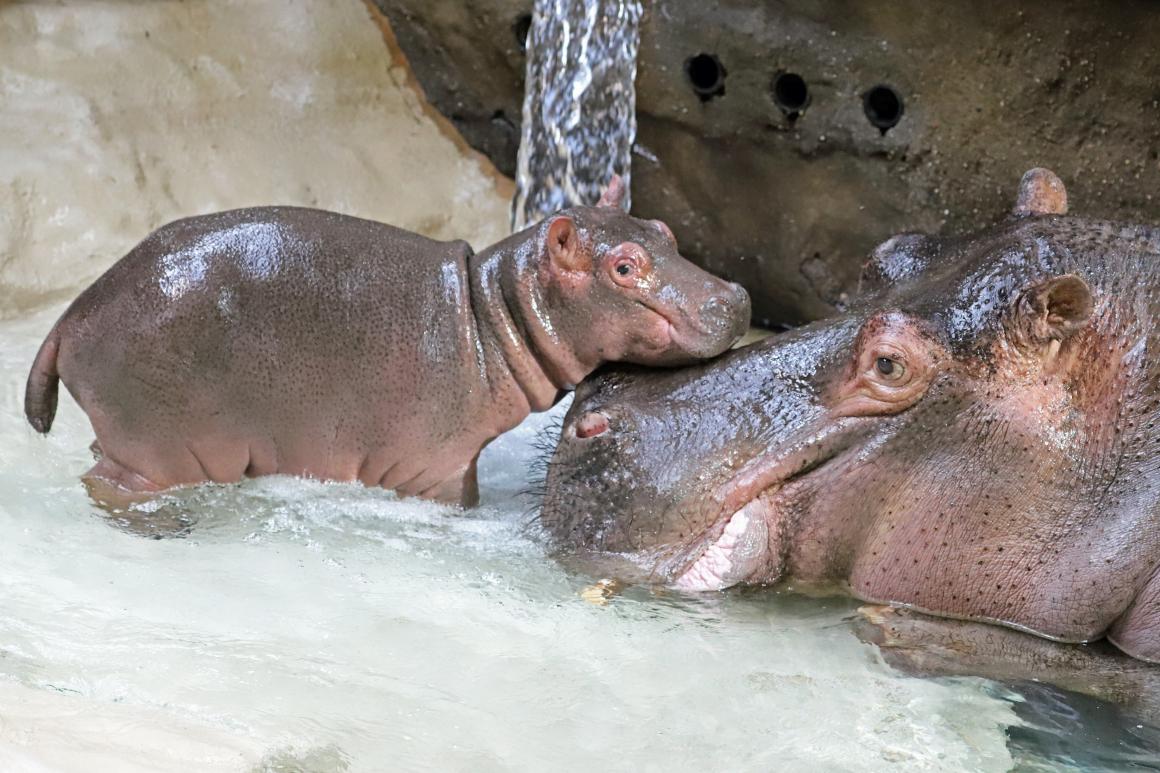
[0,304,1132,771]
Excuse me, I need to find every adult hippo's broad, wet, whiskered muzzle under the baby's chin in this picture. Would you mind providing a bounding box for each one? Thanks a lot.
[543,319,864,590]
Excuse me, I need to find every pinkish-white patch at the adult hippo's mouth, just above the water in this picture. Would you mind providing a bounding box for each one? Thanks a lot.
[673,499,769,592]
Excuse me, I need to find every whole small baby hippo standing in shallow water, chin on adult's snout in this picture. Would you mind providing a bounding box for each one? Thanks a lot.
[24,179,749,505]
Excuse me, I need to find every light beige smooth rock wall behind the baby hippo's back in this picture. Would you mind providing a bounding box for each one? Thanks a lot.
[0,0,512,316]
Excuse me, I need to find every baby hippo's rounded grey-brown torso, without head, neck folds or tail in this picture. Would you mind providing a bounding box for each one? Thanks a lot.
[57,207,484,493]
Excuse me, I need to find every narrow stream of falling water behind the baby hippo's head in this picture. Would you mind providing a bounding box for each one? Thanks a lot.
[512,0,643,229]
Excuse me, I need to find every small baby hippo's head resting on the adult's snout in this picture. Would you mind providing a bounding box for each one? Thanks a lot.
[539,178,749,366]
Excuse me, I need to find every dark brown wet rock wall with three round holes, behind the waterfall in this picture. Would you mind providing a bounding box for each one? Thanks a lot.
[375,0,1160,325]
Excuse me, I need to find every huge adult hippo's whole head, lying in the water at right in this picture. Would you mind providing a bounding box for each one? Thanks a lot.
[543,172,1160,652]
